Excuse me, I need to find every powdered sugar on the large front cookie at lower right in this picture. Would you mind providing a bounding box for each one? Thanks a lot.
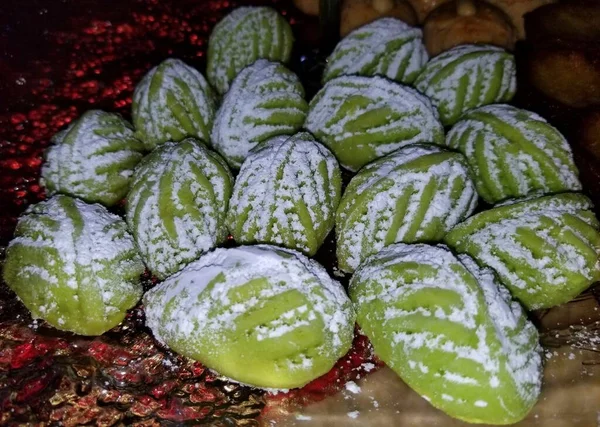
[350,244,541,416]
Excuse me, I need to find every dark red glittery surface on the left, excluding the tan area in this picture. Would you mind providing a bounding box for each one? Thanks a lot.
[0,0,379,426]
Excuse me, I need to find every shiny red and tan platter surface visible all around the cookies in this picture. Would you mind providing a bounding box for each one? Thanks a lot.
[0,0,600,426]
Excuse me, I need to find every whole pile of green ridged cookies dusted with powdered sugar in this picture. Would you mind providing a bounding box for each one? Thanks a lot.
[3,7,600,424]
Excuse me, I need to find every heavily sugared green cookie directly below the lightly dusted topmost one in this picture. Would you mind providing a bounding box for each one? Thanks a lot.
[212,59,308,169]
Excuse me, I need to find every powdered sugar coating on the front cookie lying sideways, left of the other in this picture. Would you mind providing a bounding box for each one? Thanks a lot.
[144,245,354,388]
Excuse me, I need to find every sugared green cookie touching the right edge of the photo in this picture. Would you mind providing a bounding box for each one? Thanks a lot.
[445,193,600,309]
